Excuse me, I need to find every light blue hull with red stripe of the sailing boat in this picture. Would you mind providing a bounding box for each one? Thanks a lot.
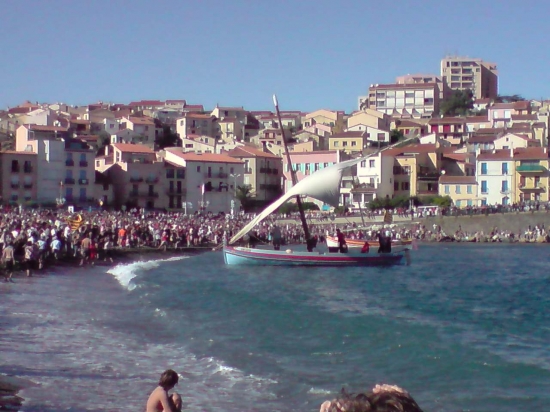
[223,246,407,266]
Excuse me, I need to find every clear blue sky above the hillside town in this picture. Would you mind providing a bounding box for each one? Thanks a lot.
[0,0,550,113]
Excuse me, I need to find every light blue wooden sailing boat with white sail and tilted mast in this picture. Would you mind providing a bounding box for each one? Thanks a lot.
[223,96,408,266]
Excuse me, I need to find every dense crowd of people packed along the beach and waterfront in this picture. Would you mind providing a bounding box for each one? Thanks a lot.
[0,205,548,281]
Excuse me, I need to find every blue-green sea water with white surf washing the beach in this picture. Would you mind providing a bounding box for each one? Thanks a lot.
[0,244,550,412]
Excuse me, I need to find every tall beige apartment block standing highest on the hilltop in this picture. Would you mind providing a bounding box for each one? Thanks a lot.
[441,56,498,99]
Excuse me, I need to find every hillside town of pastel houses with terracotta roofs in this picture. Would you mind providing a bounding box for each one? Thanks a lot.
[0,57,550,214]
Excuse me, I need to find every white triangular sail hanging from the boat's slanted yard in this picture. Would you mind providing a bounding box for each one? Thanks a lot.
[229,158,364,244]
